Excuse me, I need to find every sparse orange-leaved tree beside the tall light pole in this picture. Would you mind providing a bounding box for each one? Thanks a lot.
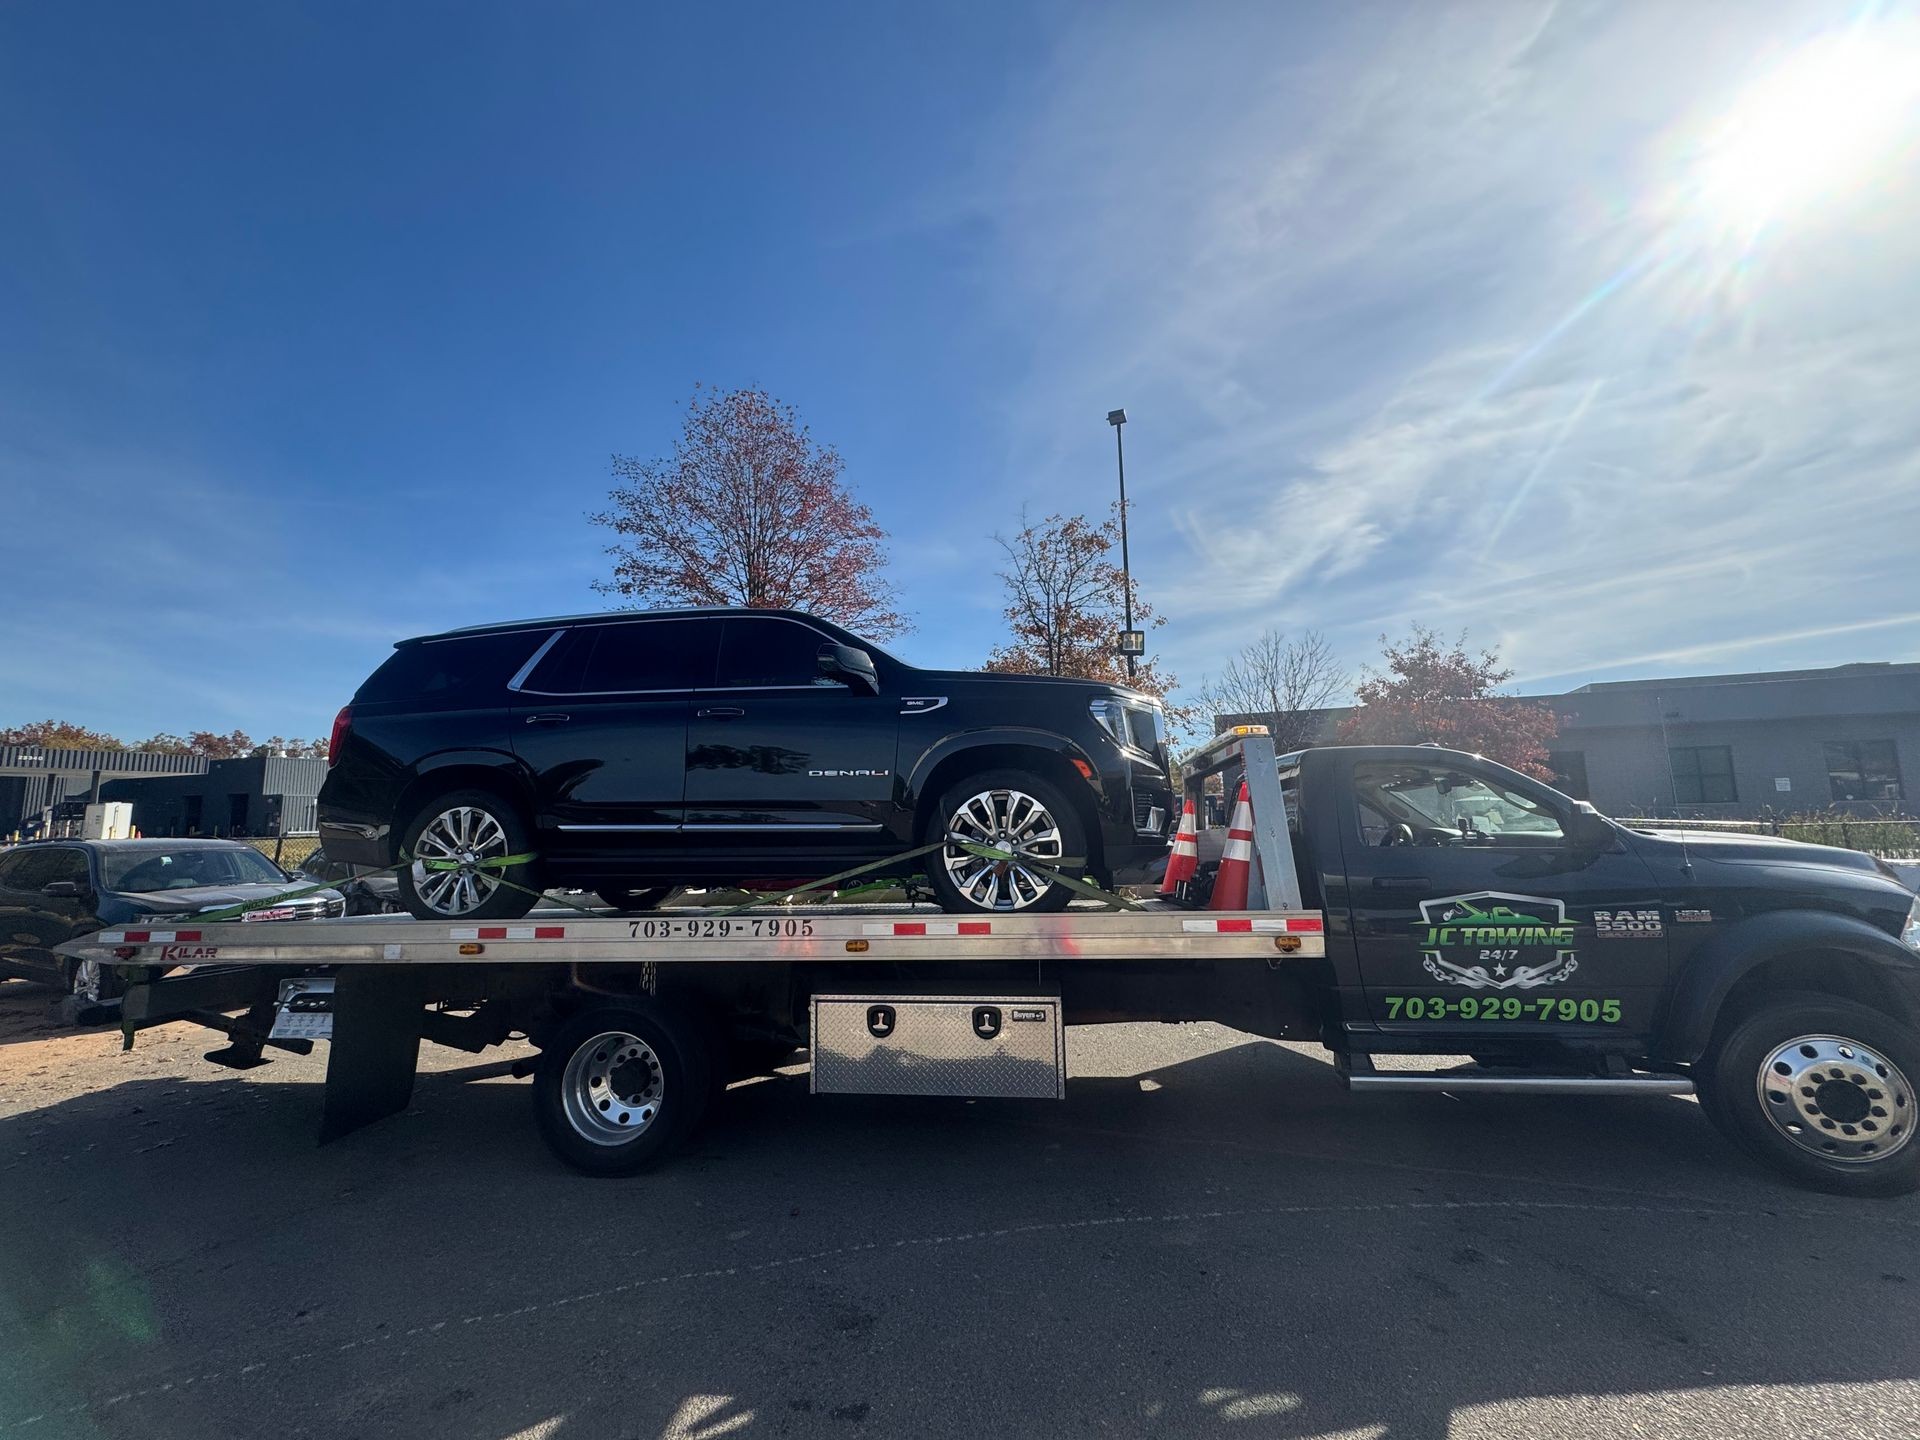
[987,505,1185,722]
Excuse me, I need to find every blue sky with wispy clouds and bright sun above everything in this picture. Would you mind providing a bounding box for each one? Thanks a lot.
[0,0,1920,735]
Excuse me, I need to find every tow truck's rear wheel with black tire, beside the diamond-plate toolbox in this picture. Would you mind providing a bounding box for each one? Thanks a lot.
[534,1000,714,1175]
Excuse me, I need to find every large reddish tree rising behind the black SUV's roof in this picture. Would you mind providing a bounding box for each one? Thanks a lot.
[591,388,908,639]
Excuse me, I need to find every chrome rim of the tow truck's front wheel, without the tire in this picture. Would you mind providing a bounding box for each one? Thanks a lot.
[1757,1035,1914,1162]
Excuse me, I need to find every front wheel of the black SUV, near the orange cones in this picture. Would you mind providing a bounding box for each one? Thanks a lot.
[922,770,1087,916]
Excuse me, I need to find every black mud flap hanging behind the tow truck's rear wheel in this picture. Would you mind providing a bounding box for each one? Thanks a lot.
[321,966,426,1144]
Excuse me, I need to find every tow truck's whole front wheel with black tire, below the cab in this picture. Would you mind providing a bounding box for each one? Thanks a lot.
[1697,995,1920,1196]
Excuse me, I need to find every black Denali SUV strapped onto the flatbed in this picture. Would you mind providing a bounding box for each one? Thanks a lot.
[319,609,1173,920]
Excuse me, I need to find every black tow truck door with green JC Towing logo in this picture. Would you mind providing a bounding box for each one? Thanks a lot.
[1340,756,1668,1048]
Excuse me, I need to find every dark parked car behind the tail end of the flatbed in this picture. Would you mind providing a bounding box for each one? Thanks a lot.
[0,839,346,1000]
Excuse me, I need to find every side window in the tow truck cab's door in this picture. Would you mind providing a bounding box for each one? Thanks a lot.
[1354,760,1565,849]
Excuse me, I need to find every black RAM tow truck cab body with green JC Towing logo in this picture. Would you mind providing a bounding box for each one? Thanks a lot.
[1279,745,1920,1066]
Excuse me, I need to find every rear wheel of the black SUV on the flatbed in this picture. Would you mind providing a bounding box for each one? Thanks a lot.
[399,789,540,920]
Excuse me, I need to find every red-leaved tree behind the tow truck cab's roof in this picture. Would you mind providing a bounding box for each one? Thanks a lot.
[1340,626,1559,780]
